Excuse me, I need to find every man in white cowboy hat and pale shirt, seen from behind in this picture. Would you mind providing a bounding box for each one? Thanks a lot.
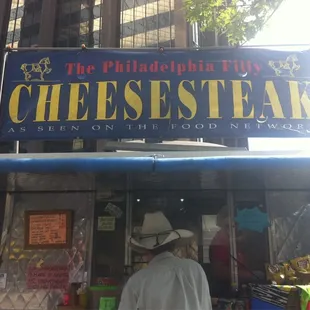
[119,212,212,310]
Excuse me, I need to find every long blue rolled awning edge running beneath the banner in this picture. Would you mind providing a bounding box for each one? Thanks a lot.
[0,151,310,173]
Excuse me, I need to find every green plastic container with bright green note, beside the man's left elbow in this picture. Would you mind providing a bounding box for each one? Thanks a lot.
[88,285,121,310]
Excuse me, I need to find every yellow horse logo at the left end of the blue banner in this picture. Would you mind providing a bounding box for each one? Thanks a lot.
[20,57,52,82]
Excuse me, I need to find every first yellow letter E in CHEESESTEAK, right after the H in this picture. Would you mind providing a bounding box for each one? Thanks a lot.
[67,83,89,121]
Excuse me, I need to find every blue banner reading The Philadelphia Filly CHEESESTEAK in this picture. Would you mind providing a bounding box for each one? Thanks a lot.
[0,48,310,141]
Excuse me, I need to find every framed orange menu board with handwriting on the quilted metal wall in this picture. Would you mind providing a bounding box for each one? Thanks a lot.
[25,210,71,249]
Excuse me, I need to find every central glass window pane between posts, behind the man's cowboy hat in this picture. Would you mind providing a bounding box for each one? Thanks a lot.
[130,171,240,297]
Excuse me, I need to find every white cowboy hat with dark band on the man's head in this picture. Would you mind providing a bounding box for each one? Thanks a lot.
[129,212,194,250]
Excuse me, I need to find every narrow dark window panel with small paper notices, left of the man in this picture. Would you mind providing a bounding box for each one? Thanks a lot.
[91,173,128,286]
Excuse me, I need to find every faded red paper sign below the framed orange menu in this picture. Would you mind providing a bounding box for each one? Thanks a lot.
[27,265,69,290]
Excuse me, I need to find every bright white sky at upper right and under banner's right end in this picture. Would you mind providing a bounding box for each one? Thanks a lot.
[246,0,310,151]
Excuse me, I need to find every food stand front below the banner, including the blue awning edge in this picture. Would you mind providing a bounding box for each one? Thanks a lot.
[0,151,310,309]
